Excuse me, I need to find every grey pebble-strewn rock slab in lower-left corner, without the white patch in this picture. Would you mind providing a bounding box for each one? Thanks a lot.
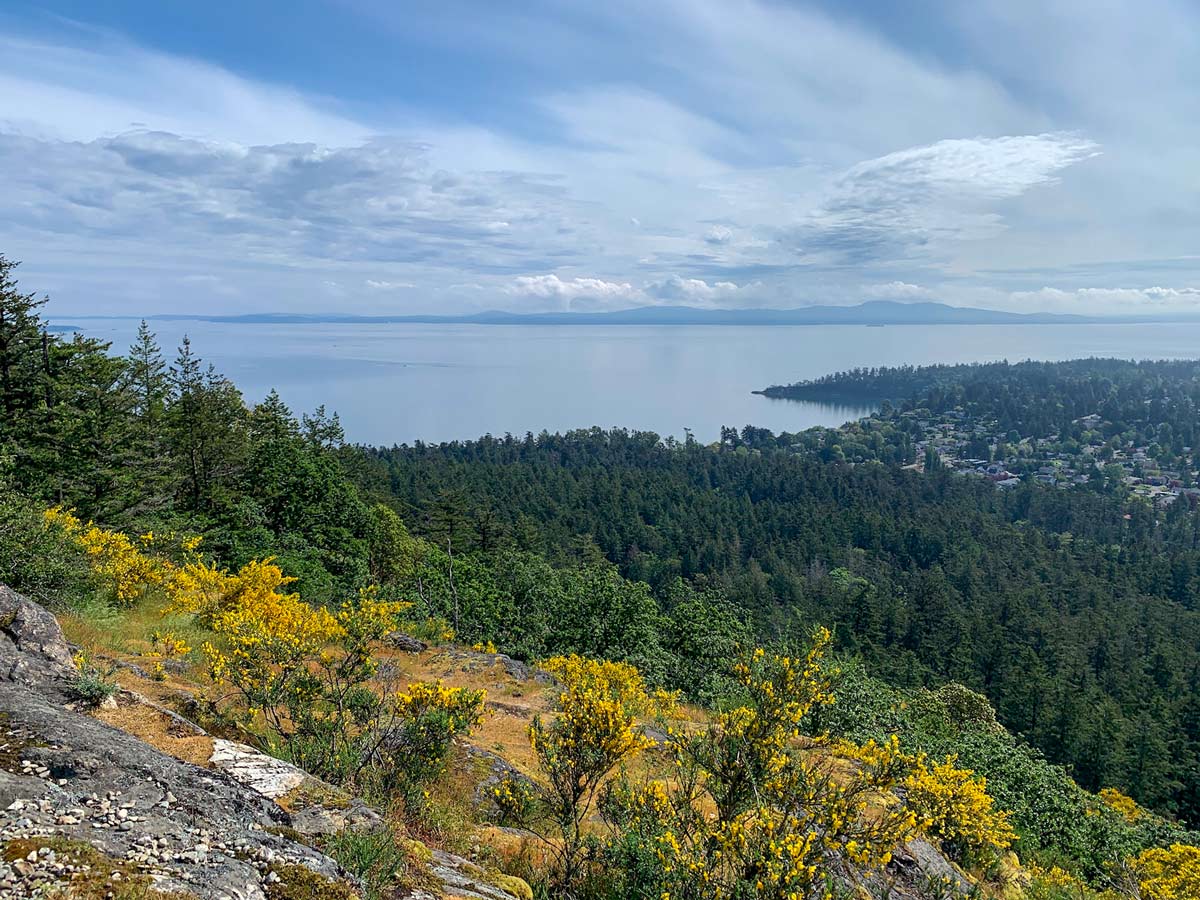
[0,586,338,900]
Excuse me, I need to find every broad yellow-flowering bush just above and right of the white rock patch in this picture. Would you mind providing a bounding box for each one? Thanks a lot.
[174,559,484,805]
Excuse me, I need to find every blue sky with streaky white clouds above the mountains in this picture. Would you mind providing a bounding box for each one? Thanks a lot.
[0,0,1200,316]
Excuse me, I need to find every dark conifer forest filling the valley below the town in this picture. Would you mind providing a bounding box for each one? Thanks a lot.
[355,427,1200,820]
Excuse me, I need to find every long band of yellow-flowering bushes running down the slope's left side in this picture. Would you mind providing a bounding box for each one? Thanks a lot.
[44,508,484,805]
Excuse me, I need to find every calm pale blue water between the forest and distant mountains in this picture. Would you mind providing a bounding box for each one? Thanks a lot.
[64,317,1200,444]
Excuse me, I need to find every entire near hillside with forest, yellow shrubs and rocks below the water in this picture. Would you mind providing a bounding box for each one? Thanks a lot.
[7,256,1200,900]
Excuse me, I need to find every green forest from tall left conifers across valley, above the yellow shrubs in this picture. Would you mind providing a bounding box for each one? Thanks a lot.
[0,258,1200,900]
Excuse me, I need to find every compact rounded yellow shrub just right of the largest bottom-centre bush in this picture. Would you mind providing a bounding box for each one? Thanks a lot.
[904,756,1016,856]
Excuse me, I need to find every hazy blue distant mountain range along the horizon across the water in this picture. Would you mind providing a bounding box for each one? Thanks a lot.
[49,300,1200,325]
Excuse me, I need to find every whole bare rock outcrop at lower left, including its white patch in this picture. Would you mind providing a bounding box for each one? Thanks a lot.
[0,584,532,900]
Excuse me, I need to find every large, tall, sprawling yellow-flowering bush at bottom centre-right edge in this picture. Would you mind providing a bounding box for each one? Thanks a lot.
[605,630,917,900]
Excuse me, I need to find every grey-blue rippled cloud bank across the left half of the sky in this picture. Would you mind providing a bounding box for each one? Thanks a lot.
[0,131,583,270]
